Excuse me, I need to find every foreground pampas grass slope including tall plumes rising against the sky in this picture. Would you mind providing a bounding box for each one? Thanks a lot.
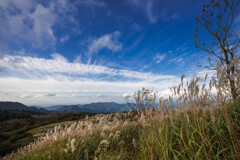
[4,78,240,160]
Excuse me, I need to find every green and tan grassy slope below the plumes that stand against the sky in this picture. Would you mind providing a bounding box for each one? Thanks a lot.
[2,97,240,160]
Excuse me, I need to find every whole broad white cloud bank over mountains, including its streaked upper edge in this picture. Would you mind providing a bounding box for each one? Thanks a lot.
[0,54,178,105]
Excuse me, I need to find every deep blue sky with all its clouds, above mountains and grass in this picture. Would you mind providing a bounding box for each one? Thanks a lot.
[0,0,219,106]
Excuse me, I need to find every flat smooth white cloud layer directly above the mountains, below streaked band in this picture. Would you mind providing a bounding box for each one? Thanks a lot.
[0,77,176,105]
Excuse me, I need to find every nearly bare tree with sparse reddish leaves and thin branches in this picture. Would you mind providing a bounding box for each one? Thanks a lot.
[193,0,240,99]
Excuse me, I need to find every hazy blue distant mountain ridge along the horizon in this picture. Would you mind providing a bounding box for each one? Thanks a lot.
[0,102,129,113]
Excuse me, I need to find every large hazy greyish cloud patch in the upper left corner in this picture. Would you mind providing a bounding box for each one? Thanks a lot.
[0,0,76,48]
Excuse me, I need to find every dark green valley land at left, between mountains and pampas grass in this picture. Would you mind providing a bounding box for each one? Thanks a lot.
[0,110,93,157]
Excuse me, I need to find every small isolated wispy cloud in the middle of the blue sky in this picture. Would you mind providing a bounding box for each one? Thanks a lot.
[87,31,122,55]
